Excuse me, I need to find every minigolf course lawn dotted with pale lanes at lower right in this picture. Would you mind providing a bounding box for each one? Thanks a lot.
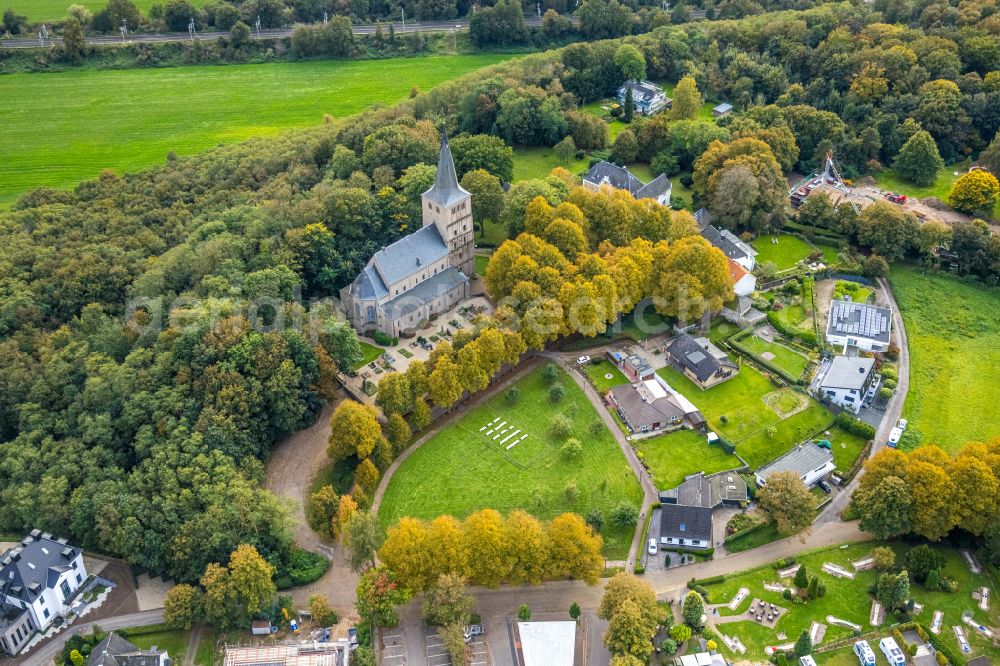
[706,544,1000,666]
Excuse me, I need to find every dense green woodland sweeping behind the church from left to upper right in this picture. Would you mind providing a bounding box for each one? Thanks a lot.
[0,0,1000,580]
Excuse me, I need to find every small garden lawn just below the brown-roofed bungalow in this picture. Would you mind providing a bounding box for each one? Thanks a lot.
[635,430,742,490]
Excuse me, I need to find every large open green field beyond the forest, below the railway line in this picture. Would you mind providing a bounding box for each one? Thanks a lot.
[0,54,512,203]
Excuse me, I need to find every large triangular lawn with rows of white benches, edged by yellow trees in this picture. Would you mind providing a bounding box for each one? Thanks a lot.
[379,368,642,559]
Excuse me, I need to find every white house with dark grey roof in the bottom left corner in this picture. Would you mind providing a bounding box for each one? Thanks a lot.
[0,530,87,655]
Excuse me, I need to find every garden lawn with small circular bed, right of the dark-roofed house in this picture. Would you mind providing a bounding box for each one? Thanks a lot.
[657,363,833,468]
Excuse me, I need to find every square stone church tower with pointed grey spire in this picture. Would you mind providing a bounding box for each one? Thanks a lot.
[421,130,476,277]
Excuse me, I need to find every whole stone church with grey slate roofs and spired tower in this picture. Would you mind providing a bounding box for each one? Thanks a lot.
[340,132,475,337]
